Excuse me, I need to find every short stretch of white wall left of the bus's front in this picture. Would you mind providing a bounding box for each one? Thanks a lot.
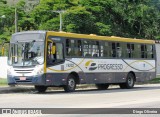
[0,57,7,78]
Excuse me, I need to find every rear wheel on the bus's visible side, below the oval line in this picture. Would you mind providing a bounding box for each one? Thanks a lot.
[119,73,135,89]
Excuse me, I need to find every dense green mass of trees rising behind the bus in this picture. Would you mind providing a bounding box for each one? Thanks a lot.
[0,0,160,40]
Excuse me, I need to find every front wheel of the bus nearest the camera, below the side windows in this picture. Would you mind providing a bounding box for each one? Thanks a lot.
[64,75,76,92]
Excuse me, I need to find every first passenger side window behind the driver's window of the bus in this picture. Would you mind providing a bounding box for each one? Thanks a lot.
[66,39,82,56]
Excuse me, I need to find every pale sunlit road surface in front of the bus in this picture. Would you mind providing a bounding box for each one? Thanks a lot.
[0,84,160,117]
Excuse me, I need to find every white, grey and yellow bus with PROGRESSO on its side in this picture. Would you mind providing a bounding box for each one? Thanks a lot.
[7,31,156,92]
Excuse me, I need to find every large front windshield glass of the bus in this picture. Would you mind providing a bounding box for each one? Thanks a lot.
[8,40,44,66]
